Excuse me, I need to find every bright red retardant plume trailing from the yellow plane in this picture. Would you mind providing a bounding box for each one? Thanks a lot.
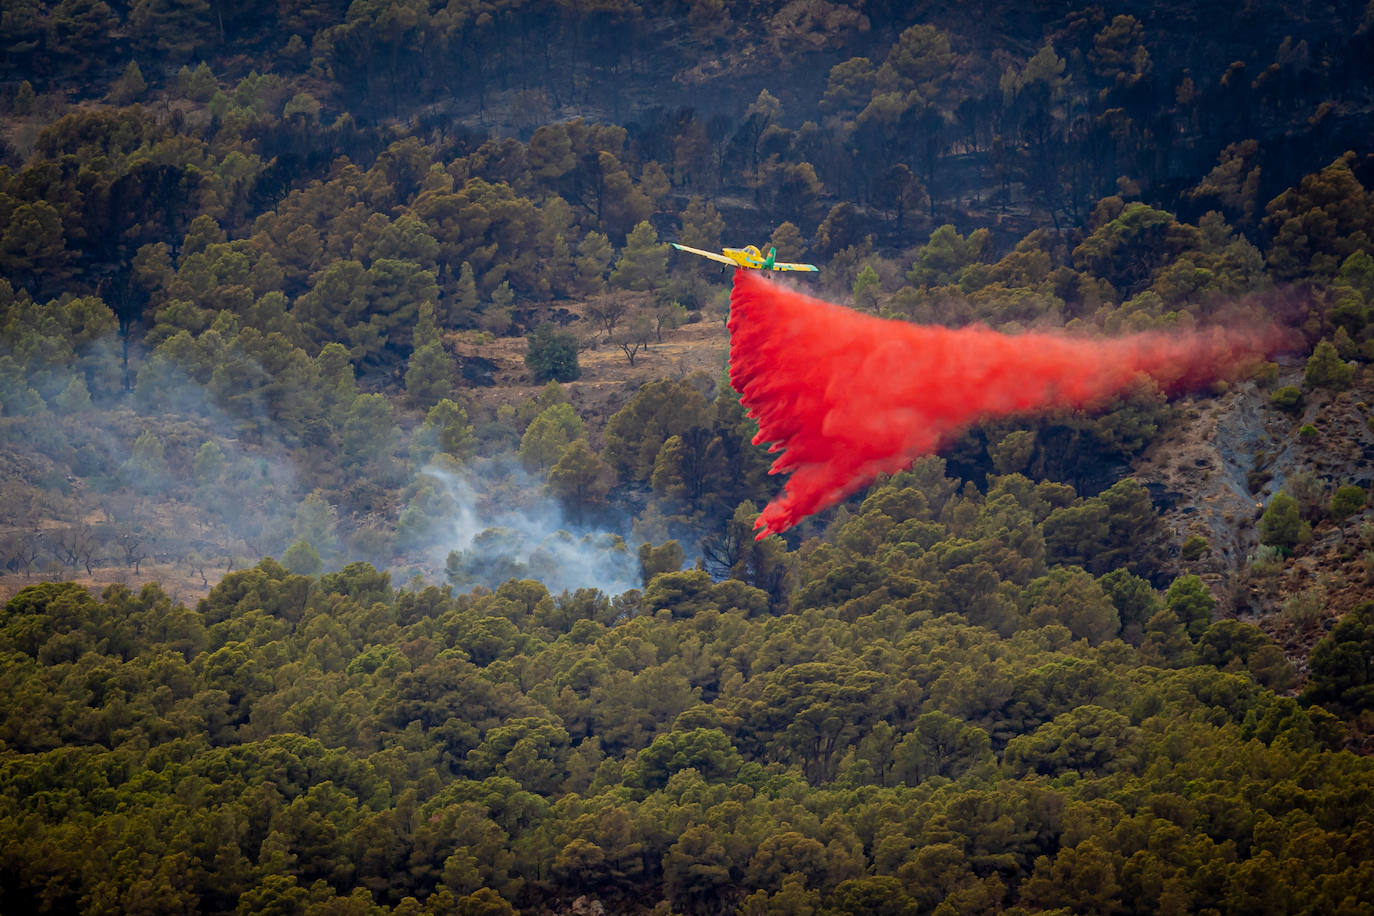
[730,269,1279,538]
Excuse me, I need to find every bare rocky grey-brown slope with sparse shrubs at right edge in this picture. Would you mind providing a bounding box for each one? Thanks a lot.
[1135,361,1374,650]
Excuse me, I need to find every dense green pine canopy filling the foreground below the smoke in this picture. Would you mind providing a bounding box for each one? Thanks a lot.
[8,549,1370,912]
